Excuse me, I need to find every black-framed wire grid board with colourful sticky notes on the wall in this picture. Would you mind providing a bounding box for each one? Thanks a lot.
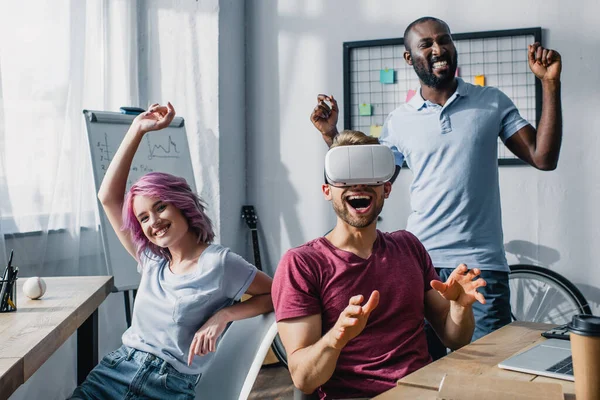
[344,28,542,165]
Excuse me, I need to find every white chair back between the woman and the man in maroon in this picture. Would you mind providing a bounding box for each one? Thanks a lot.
[196,312,277,400]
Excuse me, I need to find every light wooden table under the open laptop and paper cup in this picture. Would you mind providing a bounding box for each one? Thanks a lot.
[376,322,575,400]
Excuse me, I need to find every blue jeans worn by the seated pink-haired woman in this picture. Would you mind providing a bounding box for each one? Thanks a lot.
[71,345,200,400]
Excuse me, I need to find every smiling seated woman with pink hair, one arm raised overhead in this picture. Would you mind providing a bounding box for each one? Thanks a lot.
[71,103,273,399]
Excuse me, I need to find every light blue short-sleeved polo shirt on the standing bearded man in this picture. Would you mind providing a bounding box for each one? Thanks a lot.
[379,78,528,271]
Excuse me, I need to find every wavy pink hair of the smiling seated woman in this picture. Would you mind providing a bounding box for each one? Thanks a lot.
[121,172,215,260]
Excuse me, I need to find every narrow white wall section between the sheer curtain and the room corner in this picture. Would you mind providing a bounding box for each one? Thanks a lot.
[138,0,245,253]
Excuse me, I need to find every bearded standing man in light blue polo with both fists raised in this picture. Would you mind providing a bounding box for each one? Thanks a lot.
[311,17,562,340]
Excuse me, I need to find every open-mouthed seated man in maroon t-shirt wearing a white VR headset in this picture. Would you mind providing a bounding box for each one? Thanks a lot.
[272,131,485,399]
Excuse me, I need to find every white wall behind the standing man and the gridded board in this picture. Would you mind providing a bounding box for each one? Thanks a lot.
[246,0,600,313]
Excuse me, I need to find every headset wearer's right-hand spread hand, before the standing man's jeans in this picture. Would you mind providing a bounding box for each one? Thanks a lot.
[430,264,487,307]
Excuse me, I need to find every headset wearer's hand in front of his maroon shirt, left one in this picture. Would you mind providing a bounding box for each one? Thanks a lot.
[328,290,379,350]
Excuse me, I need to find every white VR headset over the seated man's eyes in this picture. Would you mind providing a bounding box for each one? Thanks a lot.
[325,144,396,186]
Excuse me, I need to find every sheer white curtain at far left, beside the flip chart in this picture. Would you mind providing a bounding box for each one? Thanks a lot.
[0,0,138,399]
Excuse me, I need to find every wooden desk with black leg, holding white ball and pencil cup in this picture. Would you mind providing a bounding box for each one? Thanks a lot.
[0,276,113,400]
